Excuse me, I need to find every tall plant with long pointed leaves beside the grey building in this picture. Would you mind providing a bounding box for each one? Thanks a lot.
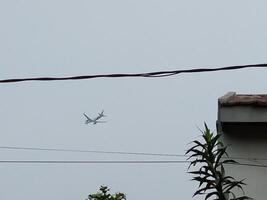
[186,124,252,200]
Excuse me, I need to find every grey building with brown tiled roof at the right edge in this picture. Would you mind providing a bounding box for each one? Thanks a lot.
[217,92,267,200]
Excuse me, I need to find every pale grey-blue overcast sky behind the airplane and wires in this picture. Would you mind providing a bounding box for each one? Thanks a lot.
[0,0,267,200]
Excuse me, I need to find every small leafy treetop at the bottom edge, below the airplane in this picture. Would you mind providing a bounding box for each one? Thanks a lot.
[86,186,126,200]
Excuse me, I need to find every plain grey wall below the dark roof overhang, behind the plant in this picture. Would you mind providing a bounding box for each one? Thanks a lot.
[222,134,267,200]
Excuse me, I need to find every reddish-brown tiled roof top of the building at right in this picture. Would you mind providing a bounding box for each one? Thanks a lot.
[219,92,267,107]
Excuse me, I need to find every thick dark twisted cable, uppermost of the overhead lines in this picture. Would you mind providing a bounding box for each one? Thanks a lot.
[0,63,267,83]
